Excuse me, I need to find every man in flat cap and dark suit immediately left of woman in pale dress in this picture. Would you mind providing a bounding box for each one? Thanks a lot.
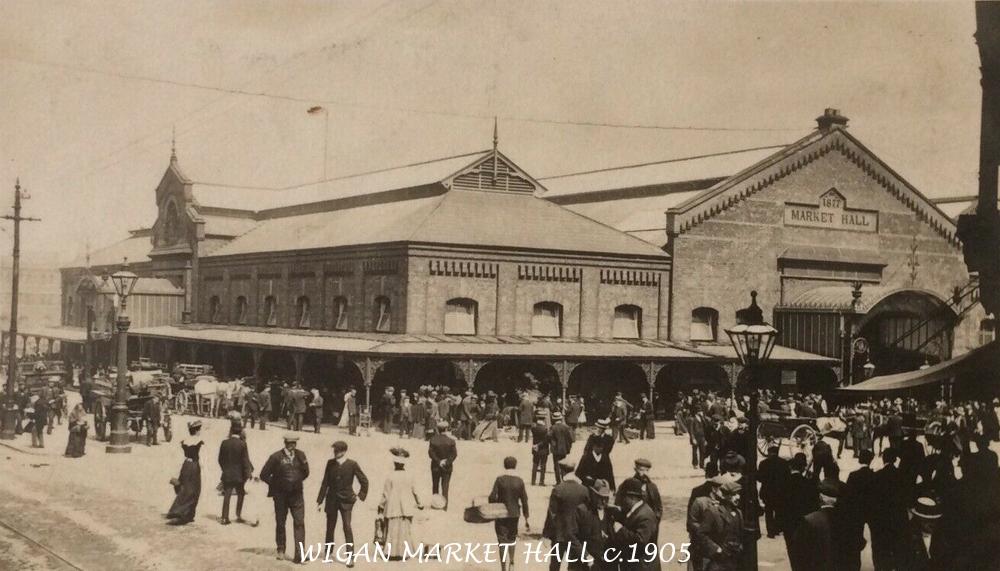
[316,440,368,567]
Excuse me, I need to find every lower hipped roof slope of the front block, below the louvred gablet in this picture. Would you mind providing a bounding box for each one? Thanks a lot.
[211,189,666,259]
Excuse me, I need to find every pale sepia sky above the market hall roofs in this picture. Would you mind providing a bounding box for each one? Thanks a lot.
[0,0,981,268]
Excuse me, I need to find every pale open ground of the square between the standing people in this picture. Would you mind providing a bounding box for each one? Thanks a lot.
[0,396,876,570]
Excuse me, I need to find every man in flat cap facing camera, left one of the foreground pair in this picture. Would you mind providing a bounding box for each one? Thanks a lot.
[260,434,309,563]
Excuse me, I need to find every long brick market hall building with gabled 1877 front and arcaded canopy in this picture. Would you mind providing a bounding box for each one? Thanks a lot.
[33,110,985,412]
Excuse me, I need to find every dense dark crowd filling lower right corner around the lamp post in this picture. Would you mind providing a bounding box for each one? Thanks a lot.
[676,391,1000,571]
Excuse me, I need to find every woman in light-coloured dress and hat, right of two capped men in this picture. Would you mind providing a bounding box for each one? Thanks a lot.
[376,448,424,560]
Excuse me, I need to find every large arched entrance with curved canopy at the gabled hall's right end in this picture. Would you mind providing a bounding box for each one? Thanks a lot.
[857,289,957,375]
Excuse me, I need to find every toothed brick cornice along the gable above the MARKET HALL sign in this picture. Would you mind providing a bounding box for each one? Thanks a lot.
[667,128,959,247]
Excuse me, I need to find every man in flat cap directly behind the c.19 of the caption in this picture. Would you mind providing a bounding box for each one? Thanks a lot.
[609,479,660,571]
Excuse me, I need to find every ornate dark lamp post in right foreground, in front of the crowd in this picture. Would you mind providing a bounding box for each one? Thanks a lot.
[726,291,778,568]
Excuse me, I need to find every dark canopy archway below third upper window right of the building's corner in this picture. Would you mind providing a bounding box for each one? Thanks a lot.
[567,361,649,418]
